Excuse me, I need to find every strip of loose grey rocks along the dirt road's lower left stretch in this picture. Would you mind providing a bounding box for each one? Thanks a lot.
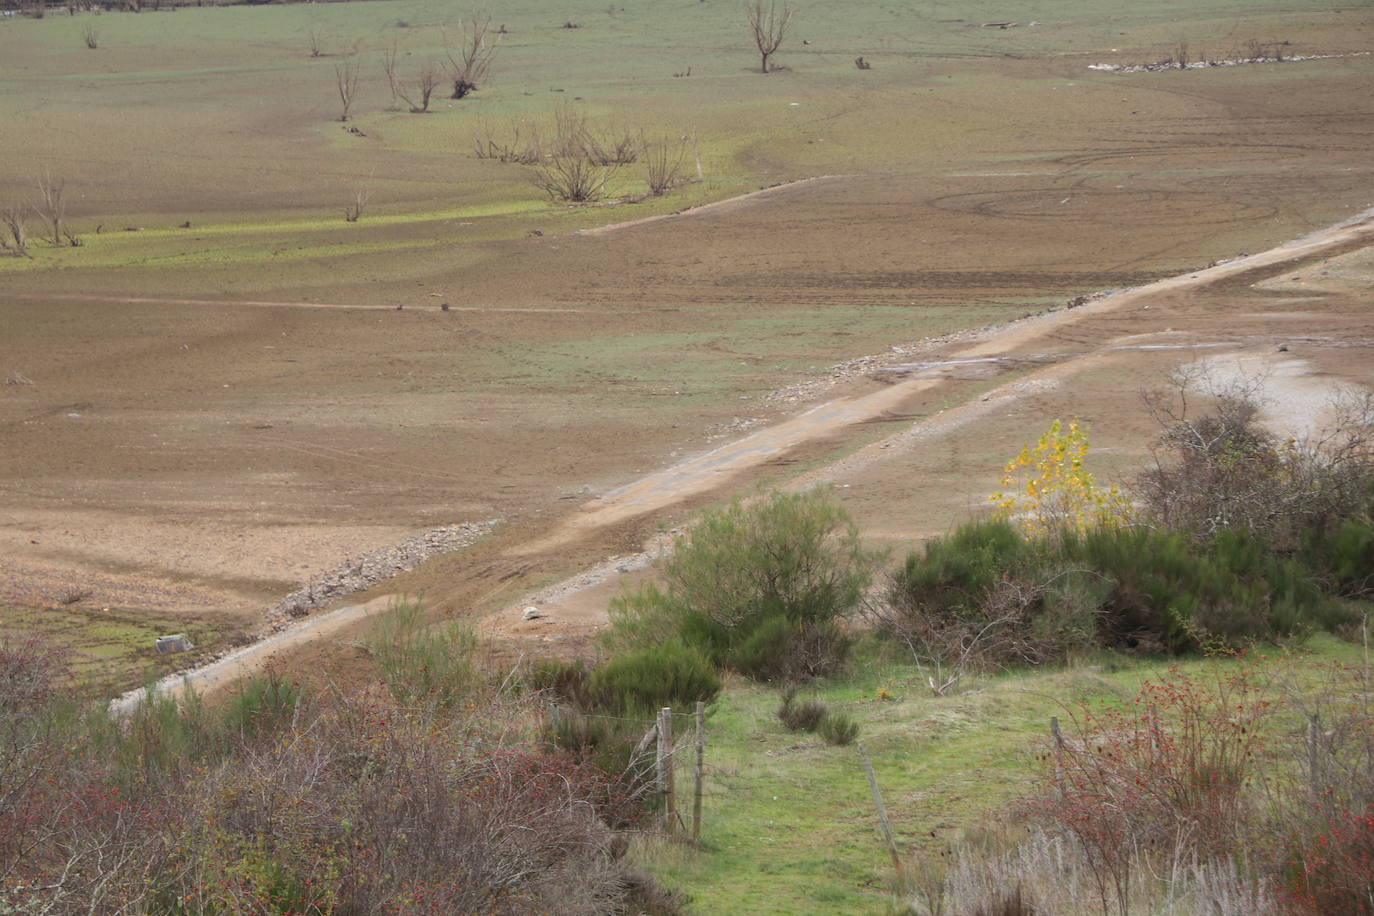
[267,519,497,632]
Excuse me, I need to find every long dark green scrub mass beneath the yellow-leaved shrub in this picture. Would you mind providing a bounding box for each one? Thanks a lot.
[870,519,1364,692]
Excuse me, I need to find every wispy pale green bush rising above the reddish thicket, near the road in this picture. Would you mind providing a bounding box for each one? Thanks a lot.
[367,602,478,707]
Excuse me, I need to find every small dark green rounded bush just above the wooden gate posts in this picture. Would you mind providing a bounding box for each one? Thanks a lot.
[588,640,721,715]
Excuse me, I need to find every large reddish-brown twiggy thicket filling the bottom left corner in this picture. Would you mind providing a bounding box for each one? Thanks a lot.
[0,626,676,916]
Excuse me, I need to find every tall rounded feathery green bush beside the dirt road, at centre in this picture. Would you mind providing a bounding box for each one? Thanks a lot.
[606,490,875,680]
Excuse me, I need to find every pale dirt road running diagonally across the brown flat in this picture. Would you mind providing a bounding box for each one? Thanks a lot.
[121,200,1374,706]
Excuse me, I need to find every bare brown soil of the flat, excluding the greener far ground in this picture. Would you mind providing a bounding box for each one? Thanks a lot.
[0,37,1374,694]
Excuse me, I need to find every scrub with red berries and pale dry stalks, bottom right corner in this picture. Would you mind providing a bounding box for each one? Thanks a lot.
[989,661,1374,916]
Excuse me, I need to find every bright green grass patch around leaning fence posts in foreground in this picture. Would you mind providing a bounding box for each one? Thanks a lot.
[635,636,1360,915]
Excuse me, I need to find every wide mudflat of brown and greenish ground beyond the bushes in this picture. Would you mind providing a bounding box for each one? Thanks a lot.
[0,3,1374,692]
